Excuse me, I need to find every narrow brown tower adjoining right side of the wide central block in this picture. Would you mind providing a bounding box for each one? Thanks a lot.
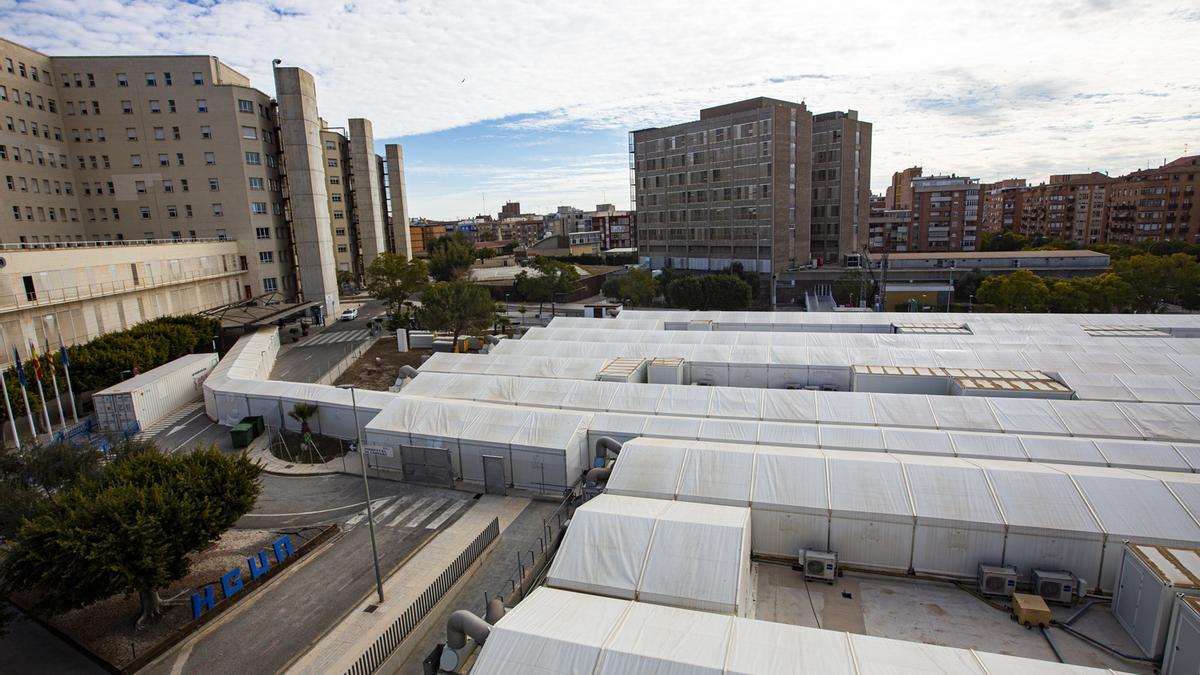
[810,110,871,262]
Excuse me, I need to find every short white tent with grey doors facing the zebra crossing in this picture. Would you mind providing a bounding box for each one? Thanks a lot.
[365,396,590,490]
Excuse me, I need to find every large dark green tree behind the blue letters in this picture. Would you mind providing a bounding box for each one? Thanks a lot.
[0,446,262,625]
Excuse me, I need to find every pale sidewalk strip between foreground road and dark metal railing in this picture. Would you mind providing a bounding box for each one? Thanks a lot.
[287,495,529,675]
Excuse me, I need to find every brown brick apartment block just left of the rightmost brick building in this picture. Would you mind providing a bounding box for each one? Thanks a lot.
[1004,172,1112,246]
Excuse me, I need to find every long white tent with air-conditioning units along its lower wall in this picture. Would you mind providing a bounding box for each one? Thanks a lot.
[606,438,1200,583]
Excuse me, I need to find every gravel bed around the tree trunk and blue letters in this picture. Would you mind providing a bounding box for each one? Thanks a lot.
[33,530,278,670]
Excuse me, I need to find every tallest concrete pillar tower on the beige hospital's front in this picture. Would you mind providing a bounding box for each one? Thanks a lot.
[275,67,338,317]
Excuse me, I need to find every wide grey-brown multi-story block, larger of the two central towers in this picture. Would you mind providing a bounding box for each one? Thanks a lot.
[629,97,816,276]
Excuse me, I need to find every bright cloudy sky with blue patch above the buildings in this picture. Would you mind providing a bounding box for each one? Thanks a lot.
[0,0,1200,219]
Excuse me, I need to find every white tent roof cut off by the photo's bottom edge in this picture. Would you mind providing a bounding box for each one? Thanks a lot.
[470,587,1116,675]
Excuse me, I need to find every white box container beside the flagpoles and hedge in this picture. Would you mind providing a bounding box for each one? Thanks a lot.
[92,354,217,431]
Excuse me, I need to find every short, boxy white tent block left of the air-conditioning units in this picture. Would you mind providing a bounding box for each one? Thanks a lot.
[546,495,751,616]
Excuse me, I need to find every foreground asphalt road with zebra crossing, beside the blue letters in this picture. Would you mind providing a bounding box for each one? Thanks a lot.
[142,476,475,675]
